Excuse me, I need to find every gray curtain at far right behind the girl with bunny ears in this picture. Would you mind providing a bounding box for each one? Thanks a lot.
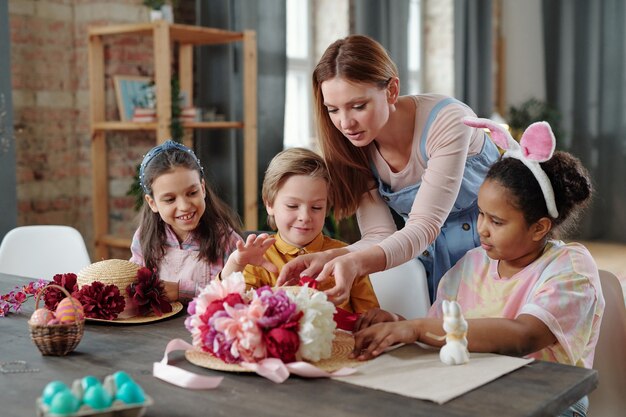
[543,0,626,242]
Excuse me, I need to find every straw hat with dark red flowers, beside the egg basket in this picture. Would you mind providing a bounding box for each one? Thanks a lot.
[76,259,183,324]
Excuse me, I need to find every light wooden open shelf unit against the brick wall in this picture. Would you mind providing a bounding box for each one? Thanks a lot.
[88,20,258,259]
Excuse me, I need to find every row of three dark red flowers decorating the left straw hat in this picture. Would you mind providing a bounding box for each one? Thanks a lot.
[44,267,172,320]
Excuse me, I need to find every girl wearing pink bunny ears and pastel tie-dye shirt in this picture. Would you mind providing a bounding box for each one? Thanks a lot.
[355,118,604,415]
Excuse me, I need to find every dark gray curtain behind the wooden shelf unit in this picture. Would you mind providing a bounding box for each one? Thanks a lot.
[195,0,287,228]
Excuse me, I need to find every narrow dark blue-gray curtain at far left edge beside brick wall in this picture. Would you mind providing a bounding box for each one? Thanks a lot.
[0,2,17,241]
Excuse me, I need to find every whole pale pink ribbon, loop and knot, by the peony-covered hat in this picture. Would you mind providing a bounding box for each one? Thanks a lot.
[152,339,356,389]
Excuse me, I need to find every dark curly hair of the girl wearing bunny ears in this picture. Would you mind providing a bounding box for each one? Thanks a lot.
[485,151,593,236]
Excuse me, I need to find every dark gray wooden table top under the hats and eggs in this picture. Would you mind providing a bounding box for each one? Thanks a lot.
[0,274,598,417]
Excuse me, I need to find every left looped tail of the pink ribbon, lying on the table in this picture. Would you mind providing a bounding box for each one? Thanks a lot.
[152,339,224,389]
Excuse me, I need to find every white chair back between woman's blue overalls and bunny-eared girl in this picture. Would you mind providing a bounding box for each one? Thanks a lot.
[370,259,430,319]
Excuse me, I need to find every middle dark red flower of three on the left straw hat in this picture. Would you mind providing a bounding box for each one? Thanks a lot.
[76,281,126,320]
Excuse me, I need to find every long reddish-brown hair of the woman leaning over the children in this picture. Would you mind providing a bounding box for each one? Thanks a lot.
[312,35,398,219]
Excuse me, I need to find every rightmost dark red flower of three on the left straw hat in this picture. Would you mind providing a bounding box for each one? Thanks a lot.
[126,267,172,317]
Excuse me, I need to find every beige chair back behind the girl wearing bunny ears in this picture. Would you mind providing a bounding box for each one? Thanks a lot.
[587,270,626,417]
